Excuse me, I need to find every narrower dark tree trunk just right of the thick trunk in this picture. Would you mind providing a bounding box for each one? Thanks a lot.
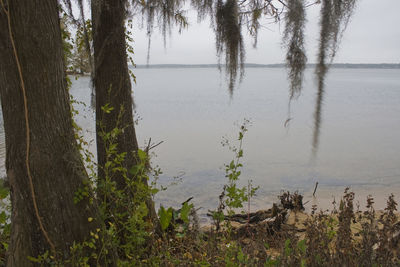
[92,0,156,222]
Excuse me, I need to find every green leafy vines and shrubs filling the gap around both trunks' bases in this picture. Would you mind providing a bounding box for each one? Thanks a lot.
[50,99,161,266]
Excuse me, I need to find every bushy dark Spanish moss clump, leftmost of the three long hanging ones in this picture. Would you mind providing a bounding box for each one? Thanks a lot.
[215,0,245,96]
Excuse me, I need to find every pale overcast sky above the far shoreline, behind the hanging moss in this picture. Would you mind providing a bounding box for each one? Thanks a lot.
[130,0,400,64]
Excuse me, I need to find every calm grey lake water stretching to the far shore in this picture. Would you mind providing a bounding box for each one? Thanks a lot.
[0,68,400,217]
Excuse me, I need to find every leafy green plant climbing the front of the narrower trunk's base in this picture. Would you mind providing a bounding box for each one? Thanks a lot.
[97,105,154,264]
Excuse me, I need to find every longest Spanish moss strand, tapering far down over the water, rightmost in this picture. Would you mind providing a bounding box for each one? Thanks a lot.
[312,0,356,156]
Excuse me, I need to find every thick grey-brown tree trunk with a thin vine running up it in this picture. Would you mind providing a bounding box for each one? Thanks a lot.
[0,0,96,266]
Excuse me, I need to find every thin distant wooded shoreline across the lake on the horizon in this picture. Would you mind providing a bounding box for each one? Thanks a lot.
[134,63,400,69]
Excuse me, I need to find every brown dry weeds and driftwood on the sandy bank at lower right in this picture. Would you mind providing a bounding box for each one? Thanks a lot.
[153,189,400,266]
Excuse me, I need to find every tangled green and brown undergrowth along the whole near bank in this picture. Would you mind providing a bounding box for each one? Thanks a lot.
[0,106,400,266]
